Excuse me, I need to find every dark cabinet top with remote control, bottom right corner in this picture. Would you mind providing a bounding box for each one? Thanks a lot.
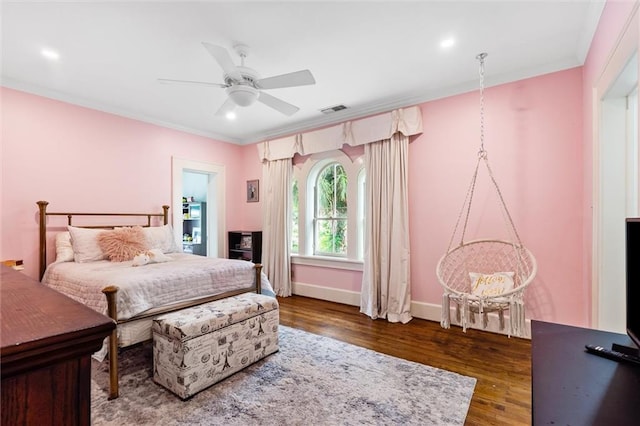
[531,320,640,426]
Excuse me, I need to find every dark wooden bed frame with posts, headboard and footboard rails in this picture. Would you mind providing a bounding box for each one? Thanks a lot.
[37,201,262,399]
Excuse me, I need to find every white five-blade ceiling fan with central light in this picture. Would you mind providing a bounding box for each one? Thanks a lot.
[158,42,316,115]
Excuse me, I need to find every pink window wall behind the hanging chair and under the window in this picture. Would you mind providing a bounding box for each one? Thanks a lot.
[264,68,589,325]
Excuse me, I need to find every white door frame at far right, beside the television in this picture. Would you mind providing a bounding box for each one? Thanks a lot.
[591,3,638,333]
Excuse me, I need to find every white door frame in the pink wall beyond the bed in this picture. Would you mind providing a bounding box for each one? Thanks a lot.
[171,157,227,257]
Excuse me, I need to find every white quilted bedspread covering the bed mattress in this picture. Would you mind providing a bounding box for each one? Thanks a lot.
[42,253,273,320]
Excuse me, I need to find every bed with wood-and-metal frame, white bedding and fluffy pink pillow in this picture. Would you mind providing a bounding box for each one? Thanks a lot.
[37,201,275,399]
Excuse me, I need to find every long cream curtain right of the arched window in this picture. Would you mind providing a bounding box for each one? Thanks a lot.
[360,133,412,323]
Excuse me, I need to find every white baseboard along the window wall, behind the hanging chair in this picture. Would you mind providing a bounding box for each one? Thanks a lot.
[291,282,531,339]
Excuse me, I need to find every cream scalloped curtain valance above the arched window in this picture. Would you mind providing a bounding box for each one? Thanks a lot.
[257,106,422,161]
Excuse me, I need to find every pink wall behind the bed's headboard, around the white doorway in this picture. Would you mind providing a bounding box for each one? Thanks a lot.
[0,88,244,277]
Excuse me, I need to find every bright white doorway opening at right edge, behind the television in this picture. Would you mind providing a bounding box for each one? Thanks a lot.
[594,53,638,333]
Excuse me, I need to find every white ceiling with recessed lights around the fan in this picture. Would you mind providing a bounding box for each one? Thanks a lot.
[1,0,604,144]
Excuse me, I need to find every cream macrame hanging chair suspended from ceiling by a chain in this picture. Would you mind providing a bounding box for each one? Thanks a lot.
[436,53,538,337]
